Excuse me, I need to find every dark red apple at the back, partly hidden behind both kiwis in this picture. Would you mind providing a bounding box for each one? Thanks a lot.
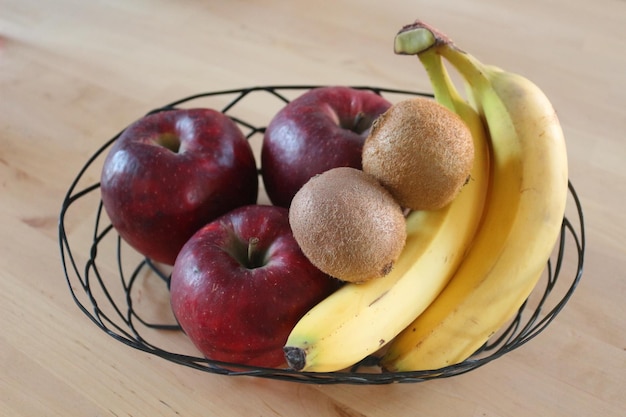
[261,86,391,207]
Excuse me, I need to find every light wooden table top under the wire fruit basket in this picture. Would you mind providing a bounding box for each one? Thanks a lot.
[0,0,626,417]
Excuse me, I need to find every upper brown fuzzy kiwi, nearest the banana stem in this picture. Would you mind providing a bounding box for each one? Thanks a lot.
[363,97,474,210]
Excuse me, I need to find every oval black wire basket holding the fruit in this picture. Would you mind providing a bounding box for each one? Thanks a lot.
[59,85,585,384]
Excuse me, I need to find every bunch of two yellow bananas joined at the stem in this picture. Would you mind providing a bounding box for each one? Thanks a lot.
[284,21,568,372]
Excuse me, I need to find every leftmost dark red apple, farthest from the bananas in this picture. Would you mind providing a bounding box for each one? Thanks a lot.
[101,108,258,265]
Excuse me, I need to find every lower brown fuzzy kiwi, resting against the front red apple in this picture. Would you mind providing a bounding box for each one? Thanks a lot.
[289,167,406,283]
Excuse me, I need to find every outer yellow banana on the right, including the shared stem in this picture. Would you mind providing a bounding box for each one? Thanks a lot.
[381,21,568,371]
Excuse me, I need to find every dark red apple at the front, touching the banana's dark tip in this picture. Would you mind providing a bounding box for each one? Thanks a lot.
[170,205,340,367]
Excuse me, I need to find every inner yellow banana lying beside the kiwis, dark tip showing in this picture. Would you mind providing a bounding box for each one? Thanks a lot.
[284,48,489,372]
